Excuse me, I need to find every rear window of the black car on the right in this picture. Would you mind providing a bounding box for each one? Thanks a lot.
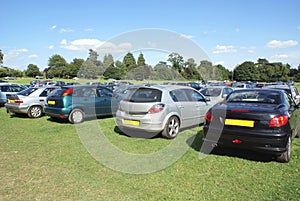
[226,91,280,104]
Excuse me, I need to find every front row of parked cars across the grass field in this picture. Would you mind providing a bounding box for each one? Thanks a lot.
[1,81,300,162]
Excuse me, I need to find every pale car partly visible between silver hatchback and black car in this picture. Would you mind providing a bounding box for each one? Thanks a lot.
[200,86,233,103]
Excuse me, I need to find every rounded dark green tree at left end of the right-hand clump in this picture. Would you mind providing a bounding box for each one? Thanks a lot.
[233,61,259,81]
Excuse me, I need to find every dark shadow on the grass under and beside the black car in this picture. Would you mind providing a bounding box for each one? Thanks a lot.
[186,130,274,162]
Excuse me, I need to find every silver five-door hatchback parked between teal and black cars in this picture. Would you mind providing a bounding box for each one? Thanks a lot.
[116,85,212,139]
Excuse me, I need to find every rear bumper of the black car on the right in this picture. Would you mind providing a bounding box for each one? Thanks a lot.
[203,126,289,155]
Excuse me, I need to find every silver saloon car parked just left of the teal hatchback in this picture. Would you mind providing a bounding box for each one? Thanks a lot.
[5,86,57,118]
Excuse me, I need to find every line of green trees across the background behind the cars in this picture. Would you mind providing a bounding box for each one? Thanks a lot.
[0,49,300,82]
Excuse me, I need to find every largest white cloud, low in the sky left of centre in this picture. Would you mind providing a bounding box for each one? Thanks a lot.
[60,39,132,53]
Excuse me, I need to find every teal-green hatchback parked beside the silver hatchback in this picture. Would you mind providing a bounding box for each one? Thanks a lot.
[45,85,119,124]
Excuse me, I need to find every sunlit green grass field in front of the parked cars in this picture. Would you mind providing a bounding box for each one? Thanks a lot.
[0,108,300,201]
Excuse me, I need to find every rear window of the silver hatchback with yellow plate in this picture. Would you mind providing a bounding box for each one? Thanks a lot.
[124,88,162,103]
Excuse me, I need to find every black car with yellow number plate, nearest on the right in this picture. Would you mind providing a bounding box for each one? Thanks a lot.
[203,89,300,162]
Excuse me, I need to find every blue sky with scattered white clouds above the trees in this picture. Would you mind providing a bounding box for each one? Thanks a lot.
[0,0,300,70]
